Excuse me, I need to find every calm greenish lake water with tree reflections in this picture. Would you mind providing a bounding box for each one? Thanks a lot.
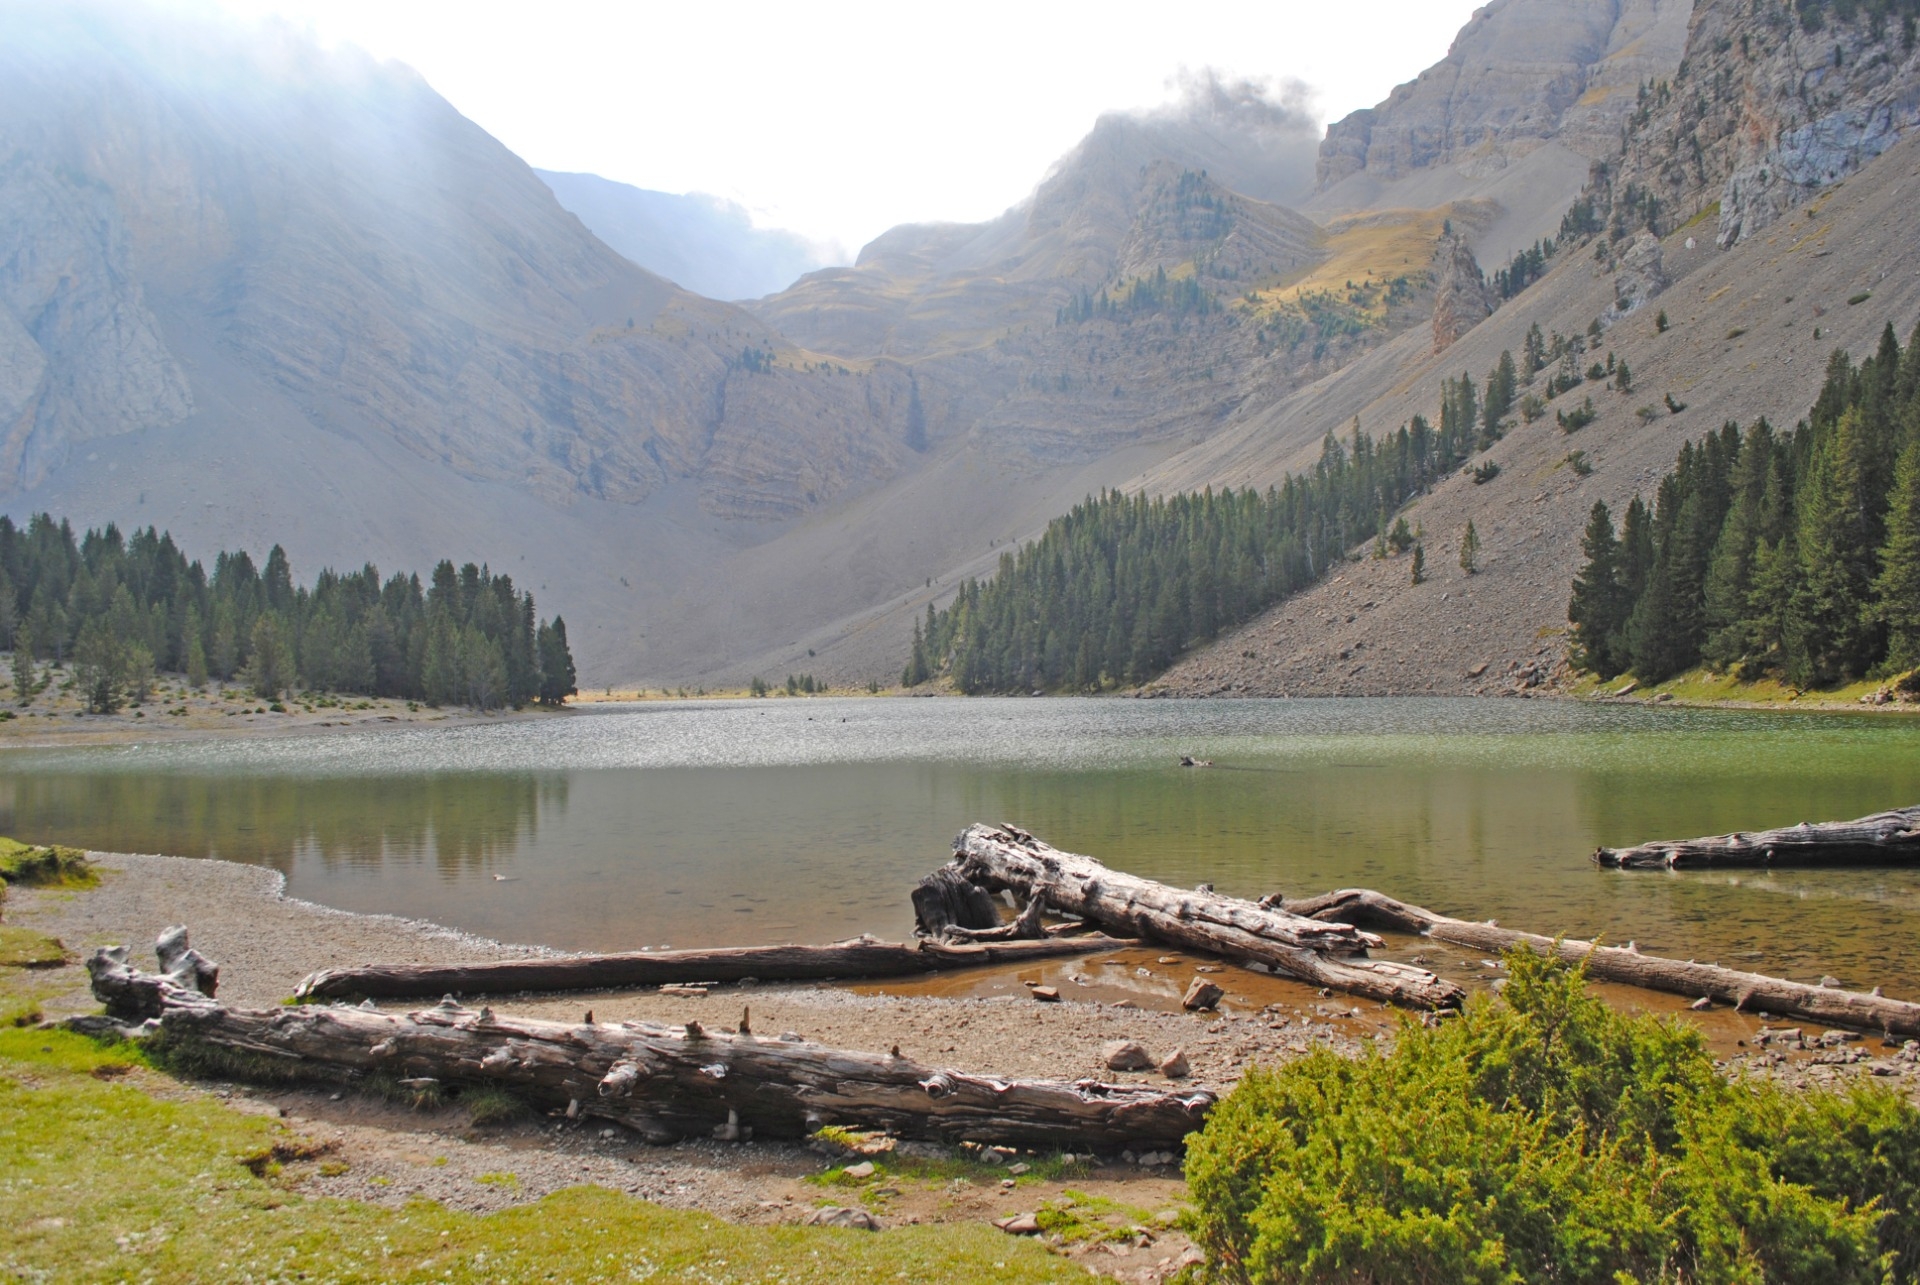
[0,699,1920,997]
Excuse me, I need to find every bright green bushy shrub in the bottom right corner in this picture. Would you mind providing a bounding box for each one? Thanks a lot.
[1187,951,1920,1285]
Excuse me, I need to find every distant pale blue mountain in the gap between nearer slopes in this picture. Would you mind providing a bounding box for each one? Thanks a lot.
[534,169,828,300]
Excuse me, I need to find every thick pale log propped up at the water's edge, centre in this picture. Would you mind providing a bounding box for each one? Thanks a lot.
[954,826,1465,1008]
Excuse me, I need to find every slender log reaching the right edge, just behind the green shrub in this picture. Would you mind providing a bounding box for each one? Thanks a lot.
[1284,887,1920,1037]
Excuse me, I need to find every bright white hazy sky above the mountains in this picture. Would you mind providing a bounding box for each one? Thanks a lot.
[217,0,1476,250]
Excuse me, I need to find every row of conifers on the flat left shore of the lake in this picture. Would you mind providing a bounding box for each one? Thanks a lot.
[0,513,574,713]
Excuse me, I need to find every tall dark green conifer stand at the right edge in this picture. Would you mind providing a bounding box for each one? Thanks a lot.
[1567,325,1920,688]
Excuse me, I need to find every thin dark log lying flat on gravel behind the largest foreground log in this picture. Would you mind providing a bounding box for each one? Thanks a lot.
[294,935,1135,999]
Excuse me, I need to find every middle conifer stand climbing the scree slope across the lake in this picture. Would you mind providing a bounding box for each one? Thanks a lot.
[900,412,1478,693]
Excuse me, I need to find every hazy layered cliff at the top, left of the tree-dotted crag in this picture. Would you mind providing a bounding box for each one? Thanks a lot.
[1315,0,1692,190]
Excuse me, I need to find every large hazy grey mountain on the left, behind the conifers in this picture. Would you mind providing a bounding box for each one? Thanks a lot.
[0,4,944,674]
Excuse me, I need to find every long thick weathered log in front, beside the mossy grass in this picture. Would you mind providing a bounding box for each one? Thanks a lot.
[86,933,1215,1149]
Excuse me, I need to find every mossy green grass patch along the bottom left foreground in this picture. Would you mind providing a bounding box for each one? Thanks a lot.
[0,1014,1085,1283]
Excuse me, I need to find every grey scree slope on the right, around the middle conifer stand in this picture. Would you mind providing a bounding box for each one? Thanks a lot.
[1140,0,1920,695]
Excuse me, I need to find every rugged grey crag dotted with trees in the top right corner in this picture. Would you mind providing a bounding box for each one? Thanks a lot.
[1607,0,1920,248]
